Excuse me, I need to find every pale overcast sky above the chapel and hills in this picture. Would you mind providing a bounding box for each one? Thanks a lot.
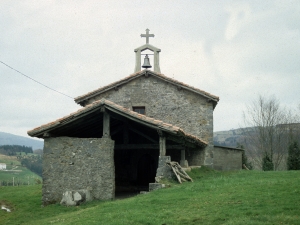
[0,0,300,137]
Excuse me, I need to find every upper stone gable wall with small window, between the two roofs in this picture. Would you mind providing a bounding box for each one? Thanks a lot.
[86,75,213,145]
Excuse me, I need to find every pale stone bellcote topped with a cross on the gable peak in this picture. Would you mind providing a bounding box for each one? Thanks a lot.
[134,29,161,73]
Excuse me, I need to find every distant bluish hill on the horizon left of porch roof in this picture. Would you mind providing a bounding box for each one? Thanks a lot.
[0,132,44,150]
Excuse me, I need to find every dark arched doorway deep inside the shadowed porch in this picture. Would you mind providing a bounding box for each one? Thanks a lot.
[137,154,156,187]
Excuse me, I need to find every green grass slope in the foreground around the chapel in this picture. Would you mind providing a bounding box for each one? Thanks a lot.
[0,168,300,225]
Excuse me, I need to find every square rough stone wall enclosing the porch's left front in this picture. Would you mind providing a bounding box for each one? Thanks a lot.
[42,137,115,205]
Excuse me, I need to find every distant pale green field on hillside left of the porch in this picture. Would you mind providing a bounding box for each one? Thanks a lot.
[0,154,41,185]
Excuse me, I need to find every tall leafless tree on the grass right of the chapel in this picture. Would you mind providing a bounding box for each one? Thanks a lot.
[243,96,296,170]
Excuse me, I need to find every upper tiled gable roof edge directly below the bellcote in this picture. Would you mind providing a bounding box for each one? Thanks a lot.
[75,70,219,104]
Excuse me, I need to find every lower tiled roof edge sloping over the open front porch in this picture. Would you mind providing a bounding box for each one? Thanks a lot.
[27,99,207,146]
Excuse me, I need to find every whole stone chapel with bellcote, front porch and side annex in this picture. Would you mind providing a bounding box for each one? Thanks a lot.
[28,29,242,205]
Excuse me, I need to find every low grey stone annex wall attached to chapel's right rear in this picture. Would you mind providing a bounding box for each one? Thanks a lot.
[213,146,243,170]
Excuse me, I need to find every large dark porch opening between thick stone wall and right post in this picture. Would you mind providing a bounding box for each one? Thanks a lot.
[111,118,159,198]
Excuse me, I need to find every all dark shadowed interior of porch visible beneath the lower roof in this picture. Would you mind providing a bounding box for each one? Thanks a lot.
[39,109,188,198]
